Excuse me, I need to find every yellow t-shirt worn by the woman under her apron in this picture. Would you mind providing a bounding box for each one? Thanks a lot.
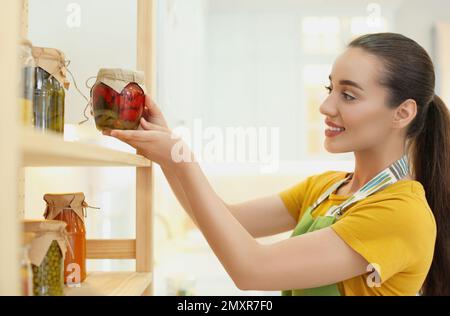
[279,171,436,295]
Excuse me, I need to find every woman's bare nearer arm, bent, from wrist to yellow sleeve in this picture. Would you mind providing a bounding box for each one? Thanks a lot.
[174,162,368,290]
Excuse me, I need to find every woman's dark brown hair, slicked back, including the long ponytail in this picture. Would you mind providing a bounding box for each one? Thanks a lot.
[349,33,450,295]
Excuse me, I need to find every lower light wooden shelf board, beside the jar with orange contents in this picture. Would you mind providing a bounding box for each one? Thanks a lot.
[64,272,152,296]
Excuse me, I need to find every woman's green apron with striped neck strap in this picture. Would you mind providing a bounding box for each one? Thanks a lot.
[281,155,409,296]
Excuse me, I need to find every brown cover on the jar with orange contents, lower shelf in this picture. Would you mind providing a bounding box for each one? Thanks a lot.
[44,192,88,221]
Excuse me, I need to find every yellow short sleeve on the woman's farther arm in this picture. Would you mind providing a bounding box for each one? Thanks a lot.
[279,175,317,220]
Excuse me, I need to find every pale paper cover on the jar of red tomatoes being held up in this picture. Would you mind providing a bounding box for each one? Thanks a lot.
[96,68,145,93]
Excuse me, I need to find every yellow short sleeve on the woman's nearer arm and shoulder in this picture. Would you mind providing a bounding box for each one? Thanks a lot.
[331,194,435,283]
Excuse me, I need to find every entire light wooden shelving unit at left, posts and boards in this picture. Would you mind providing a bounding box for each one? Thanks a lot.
[0,0,157,296]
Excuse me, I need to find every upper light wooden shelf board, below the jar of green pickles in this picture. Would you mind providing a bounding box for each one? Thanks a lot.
[21,128,151,167]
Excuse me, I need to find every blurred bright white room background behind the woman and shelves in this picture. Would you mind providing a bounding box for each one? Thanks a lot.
[25,0,450,295]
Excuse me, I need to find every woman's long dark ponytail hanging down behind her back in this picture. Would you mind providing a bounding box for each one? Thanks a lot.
[411,95,450,296]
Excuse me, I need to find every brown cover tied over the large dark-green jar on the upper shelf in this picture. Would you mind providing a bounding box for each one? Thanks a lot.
[32,47,70,90]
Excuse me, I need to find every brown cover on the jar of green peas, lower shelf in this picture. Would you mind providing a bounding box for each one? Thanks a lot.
[23,220,68,266]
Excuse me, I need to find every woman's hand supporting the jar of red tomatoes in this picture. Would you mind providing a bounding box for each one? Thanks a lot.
[103,118,194,167]
